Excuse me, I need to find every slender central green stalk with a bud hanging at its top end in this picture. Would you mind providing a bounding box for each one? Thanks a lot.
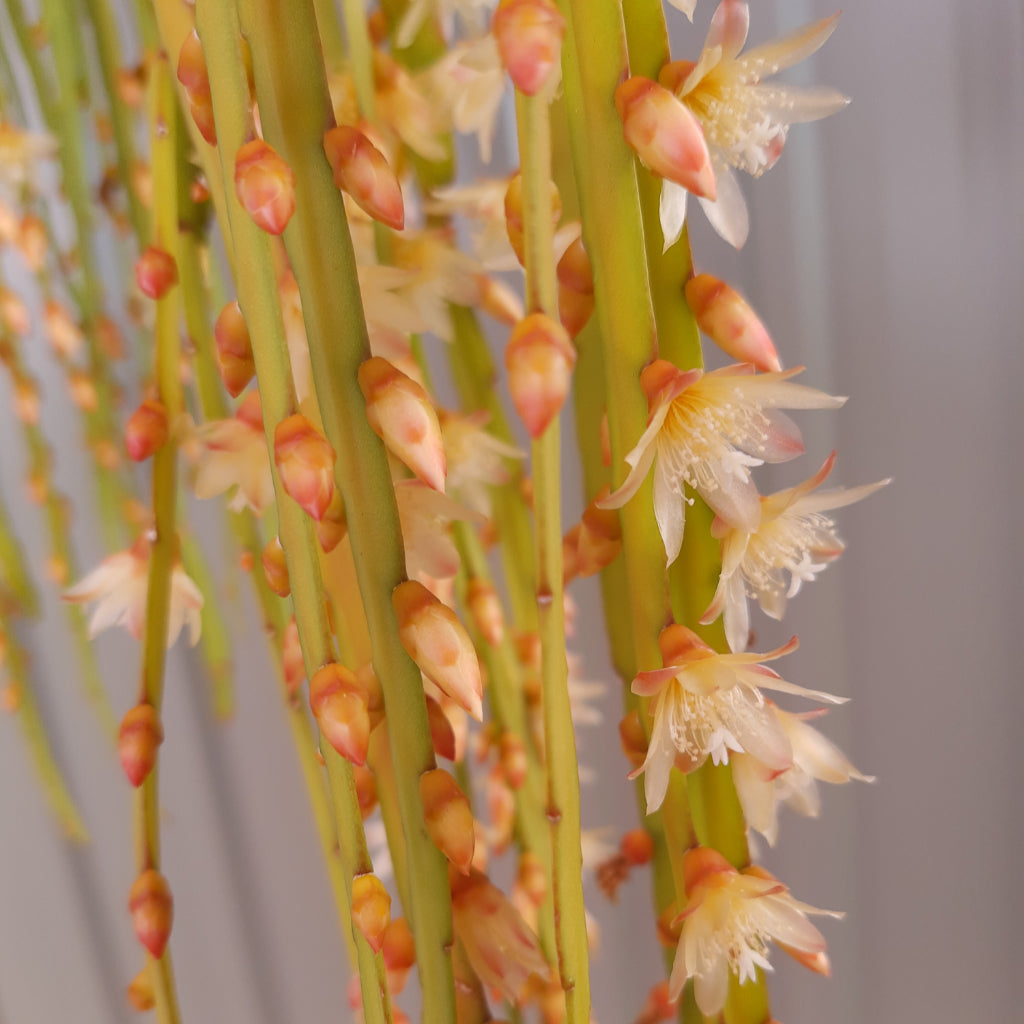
[516,83,590,1024]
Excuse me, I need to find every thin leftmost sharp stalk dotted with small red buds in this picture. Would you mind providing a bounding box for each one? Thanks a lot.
[135,59,184,1024]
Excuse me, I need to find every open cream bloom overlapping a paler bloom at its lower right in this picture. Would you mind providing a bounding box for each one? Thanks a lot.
[630,625,844,814]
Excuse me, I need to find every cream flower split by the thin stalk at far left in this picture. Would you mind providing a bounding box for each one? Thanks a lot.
[63,536,203,647]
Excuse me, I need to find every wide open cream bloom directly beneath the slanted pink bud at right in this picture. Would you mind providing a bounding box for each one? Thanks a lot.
[598,359,846,565]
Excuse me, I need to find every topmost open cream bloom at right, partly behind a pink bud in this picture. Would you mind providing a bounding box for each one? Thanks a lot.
[658,0,849,249]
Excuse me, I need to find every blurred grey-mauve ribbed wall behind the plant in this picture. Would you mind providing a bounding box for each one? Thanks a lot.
[0,0,1024,1024]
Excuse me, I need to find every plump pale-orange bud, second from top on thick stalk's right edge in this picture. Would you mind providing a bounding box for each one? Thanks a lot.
[359,355,447,494]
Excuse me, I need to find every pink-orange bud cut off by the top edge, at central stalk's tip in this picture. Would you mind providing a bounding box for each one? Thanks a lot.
[490,0,565,96]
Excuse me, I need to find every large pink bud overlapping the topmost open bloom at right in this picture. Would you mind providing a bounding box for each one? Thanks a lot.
[615,75,717,200]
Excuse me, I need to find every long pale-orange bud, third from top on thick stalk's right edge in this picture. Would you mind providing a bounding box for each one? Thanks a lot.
[391,580,483,721]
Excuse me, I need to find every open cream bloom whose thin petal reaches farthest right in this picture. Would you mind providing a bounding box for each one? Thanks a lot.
[700,452,889,650]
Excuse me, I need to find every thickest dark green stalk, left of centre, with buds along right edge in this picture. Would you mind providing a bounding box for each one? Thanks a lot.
[237,0,455,1024]
